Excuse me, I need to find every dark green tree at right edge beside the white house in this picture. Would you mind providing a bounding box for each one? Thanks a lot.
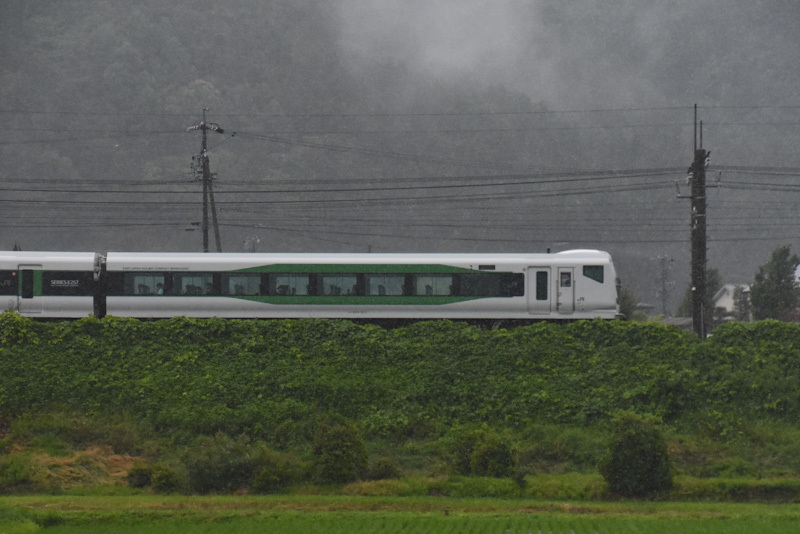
[750,245,800,320]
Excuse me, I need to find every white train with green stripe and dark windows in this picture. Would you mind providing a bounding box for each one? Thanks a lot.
[0,250,619,321]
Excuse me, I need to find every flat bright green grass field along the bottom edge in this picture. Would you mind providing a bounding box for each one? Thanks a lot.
[0,496,800,534]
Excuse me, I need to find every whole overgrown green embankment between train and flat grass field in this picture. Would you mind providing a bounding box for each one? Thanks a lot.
[0,313,800,502]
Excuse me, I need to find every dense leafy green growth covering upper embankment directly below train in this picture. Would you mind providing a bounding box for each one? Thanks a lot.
[0,312,800,439]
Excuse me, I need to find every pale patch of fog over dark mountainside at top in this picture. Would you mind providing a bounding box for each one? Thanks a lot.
[341,0,558,99]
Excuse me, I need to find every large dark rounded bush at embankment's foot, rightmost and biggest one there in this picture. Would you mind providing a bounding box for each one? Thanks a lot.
[600,413,672,497]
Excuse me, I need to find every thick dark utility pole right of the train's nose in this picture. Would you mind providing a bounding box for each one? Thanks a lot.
[689,104,711,339]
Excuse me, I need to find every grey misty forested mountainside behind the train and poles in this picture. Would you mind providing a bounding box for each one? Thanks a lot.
[0,0,800,310]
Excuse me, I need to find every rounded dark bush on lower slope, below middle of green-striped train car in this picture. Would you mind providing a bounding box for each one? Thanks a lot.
[313,423,367,483]
